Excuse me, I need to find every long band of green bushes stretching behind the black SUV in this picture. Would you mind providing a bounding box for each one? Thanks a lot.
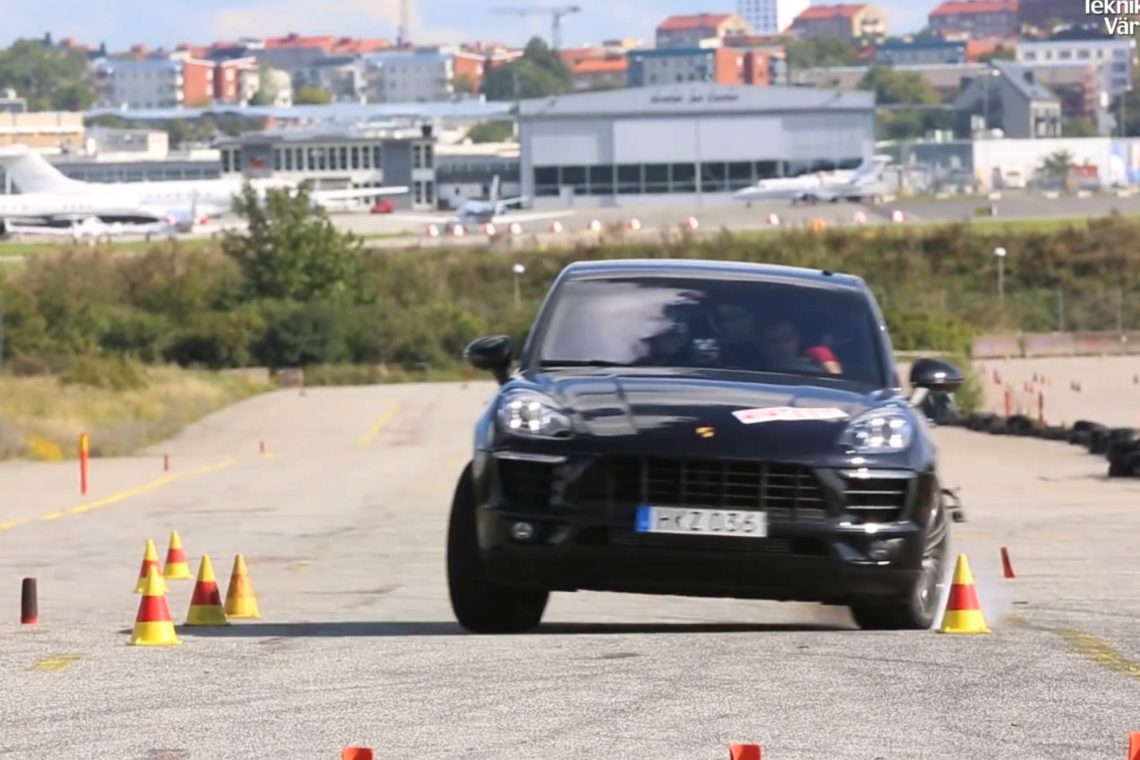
[0,201,1140,382]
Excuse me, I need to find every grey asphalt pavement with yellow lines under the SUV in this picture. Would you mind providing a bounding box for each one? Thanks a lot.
[0,359,1140,760]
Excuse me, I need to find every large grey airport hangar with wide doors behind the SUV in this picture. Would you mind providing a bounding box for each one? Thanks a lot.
[518,82,876,207]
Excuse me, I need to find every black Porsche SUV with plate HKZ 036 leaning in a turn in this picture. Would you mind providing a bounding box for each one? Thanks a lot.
[447,260,962,632]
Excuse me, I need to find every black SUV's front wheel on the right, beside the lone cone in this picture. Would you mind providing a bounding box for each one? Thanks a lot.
[850,490,950,630]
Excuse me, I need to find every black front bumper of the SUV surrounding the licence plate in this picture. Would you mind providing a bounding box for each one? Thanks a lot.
[475,452,937,604]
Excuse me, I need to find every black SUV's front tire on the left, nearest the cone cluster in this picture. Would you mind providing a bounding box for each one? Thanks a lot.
[447,464,549,634]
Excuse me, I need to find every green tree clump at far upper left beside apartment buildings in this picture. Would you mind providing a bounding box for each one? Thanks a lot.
[0,40,96,111]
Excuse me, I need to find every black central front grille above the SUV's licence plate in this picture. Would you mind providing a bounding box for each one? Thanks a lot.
[568,457,827,520]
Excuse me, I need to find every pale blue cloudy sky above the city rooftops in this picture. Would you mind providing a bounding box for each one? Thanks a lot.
[0,0,937,50]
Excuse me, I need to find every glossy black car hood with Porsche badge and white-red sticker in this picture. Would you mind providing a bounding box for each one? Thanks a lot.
[540,373,888,459]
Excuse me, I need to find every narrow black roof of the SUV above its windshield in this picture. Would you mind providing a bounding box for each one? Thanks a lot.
[562,259,866,291]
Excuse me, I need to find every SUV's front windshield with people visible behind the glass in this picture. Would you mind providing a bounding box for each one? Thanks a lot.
[537,277,886,387]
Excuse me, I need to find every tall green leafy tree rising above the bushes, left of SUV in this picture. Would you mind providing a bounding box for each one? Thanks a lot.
[222,183,364,303]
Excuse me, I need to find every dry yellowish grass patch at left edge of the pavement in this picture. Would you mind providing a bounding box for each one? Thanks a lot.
[0,367,270,460]
